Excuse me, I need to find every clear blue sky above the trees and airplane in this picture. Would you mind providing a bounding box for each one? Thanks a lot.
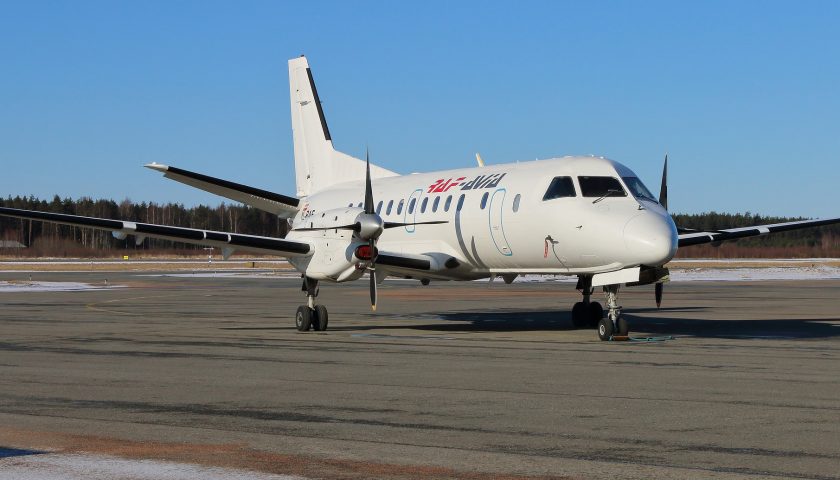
[0,1,840,217]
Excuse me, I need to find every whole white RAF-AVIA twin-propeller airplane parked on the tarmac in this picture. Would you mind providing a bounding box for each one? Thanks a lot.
[0,57,840,340]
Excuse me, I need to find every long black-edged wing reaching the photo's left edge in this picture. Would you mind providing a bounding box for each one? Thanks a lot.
[0,207,312,257]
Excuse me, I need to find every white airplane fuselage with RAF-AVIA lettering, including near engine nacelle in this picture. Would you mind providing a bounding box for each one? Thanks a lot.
[287,157,677,281]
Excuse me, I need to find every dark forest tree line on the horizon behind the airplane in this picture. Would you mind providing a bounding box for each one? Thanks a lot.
[0,195,840,258]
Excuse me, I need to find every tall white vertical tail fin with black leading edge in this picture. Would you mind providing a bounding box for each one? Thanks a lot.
[289,56,398,197]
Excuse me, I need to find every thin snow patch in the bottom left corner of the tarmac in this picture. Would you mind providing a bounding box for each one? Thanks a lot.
[0,454,303,480]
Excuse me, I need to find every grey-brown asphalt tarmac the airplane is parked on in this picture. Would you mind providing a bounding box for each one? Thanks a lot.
[0,272,840,479]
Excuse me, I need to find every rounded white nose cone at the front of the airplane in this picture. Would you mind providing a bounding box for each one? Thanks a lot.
[624,211,678,267]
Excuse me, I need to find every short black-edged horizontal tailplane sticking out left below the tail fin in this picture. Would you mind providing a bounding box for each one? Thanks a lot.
[146,163,300,218]
